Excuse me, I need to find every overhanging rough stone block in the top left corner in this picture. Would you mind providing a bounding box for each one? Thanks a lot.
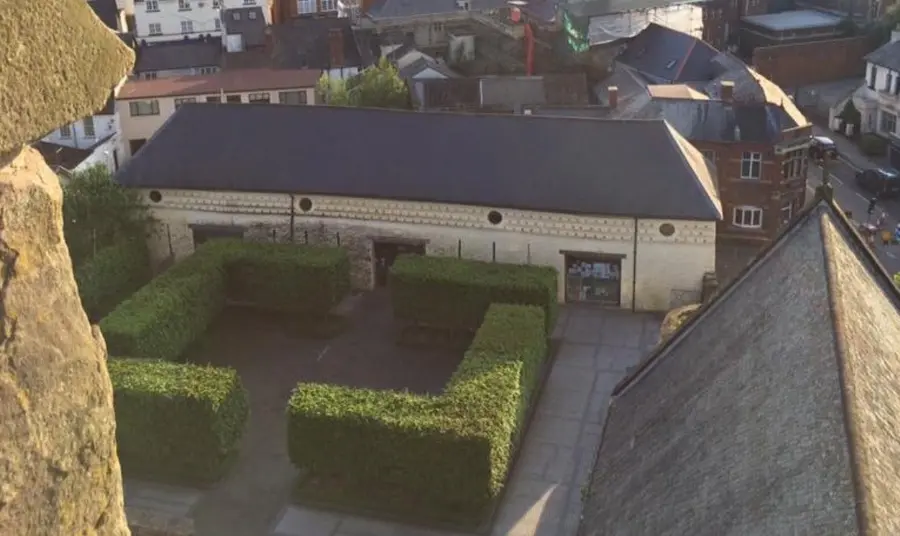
[0,0,134,155]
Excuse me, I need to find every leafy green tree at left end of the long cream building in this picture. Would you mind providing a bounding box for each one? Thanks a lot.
[63,165,151,266]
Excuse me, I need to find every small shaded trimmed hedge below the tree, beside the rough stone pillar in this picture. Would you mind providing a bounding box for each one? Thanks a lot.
[75,241,151,322]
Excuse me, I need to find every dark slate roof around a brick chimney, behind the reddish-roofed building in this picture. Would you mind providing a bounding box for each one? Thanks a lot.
[271,17,371,69]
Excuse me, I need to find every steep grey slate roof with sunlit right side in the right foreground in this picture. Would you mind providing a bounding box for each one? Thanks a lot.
[579,196,900,536]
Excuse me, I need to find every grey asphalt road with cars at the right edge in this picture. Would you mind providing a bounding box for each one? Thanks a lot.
[807,160,900,274]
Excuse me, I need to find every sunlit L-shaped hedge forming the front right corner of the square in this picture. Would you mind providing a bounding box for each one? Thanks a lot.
[287,304,548,521]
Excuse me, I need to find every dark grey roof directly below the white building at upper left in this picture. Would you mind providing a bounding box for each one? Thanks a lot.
[134,38,222,73]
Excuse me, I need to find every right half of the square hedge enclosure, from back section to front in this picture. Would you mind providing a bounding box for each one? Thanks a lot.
[288,256,557,526]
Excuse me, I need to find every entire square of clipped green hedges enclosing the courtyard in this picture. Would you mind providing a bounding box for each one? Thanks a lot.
[98,240,557,527]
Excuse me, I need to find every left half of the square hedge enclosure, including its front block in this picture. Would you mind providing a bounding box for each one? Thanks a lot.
[100,240,350,485]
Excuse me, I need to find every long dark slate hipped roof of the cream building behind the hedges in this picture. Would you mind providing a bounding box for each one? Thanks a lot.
[117,104,721,221]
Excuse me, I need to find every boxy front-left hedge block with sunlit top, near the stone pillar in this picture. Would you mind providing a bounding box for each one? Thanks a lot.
[108,359,249,484]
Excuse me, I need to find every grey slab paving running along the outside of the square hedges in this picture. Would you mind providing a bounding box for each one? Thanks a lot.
[126,305,661,536]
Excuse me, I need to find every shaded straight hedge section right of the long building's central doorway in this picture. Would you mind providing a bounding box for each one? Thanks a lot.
[390,255,558,334]
